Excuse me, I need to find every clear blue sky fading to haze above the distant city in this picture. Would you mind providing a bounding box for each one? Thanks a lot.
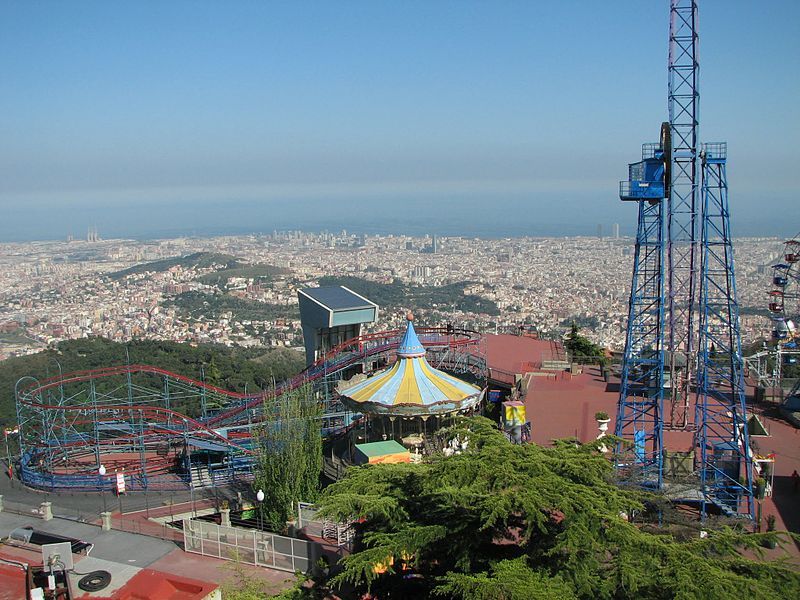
[0,0,800,239]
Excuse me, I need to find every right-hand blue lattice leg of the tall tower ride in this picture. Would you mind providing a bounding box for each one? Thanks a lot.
[695,142,755,518]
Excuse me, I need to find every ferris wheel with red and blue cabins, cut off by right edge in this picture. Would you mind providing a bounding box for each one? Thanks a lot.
[768,233,800,376]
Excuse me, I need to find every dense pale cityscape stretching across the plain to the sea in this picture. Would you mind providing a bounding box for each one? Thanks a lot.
[0,229,782,358]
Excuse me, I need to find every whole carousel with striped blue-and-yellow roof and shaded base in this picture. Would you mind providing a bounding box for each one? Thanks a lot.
[338,313,484,450]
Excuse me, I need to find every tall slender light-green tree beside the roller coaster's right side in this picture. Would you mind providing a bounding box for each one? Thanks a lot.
[255,384,322,531]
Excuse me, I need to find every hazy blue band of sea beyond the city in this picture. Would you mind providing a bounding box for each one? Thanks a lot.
[0,194,800,242]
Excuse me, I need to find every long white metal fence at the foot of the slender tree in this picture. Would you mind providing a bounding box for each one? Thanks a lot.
[183,519,322,573]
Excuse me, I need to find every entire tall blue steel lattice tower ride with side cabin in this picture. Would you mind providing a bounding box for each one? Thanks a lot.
[616,0,753,517]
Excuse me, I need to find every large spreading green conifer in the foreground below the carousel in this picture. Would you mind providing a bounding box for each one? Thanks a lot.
[318,418,800,600]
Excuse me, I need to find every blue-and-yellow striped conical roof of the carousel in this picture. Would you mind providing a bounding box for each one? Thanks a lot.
[341,319,481,414]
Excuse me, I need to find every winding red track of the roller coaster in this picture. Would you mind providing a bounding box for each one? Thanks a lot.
[16,328,485,488]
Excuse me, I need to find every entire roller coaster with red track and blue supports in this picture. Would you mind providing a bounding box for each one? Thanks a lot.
[15,326,488,491]
